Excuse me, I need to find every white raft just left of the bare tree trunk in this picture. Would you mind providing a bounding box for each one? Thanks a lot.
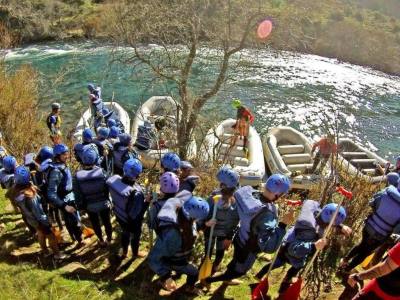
[132,96,196,168]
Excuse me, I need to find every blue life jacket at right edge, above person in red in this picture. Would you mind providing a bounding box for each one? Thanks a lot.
[367,186,400,237]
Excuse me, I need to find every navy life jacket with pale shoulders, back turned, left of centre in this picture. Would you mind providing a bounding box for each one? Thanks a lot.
[76,167,108,212]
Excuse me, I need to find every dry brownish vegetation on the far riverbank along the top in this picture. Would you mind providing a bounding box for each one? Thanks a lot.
[0,0,400,74]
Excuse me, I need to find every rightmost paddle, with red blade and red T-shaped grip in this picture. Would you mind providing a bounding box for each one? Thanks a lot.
[279,187,353,300]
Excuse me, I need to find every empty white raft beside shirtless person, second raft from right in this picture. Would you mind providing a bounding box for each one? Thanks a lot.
[263,126,329,190]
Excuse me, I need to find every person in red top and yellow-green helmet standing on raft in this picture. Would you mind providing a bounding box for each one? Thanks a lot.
[231,99,254,156]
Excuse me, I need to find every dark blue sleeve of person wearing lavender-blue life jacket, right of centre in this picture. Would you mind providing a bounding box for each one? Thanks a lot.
[257,212,286,253]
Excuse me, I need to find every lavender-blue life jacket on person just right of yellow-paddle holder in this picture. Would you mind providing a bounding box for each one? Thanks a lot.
[234,186,266,245]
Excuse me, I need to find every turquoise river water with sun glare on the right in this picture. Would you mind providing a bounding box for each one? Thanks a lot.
[6,43,400,159]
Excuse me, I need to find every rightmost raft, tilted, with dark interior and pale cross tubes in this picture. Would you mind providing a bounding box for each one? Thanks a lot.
[338,138,387,183]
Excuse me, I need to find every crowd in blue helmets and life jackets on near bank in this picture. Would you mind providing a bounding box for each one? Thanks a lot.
[0,86,400,299]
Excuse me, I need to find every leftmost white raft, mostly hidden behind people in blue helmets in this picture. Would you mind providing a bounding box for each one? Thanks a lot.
[73,102,130,142]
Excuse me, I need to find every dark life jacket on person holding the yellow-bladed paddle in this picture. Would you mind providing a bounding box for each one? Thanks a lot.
[208,191,239,237]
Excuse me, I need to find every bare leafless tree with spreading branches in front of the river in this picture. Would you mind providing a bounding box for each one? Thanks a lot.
[107,0,265,157]
